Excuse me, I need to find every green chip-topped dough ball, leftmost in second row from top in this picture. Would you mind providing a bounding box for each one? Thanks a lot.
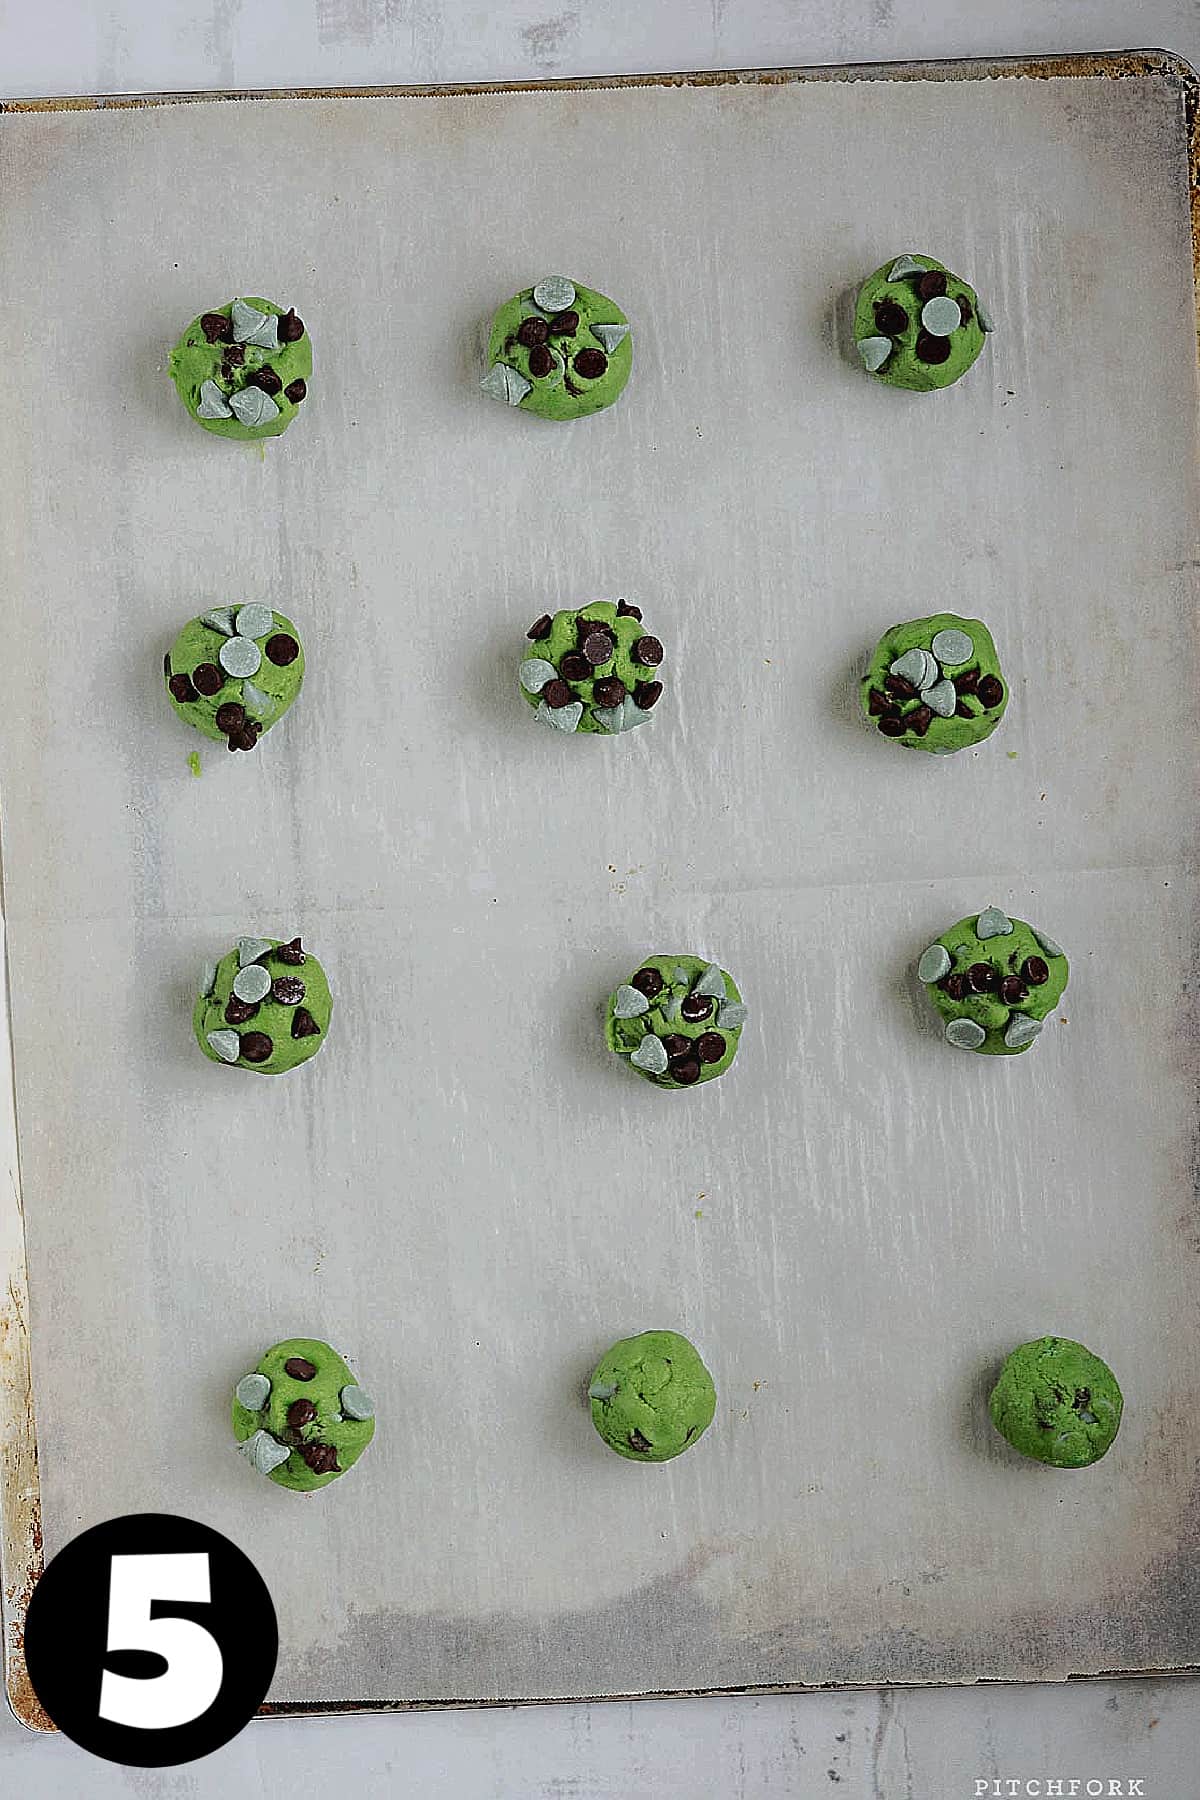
[162,601,304,751]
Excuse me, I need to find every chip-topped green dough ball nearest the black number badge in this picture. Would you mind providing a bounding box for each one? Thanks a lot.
[234,1337,374,1494]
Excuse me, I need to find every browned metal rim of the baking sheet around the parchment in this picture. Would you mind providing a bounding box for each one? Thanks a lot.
[0,50,1200,1732]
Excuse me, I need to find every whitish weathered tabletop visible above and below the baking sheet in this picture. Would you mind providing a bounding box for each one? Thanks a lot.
[0,0,1200,1800]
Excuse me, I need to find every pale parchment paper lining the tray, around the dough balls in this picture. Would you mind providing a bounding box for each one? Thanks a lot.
[0,59,1200,1712]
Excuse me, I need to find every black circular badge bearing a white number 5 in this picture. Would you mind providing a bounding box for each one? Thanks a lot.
[25,1512,279,1769]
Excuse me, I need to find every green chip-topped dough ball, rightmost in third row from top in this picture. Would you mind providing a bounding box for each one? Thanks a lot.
[918,905,1069,1057]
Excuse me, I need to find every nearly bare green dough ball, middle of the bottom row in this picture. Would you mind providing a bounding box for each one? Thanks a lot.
[588,1332,716,1462]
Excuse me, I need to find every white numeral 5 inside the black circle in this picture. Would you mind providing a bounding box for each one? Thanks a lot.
[101,1552,225,1732]
